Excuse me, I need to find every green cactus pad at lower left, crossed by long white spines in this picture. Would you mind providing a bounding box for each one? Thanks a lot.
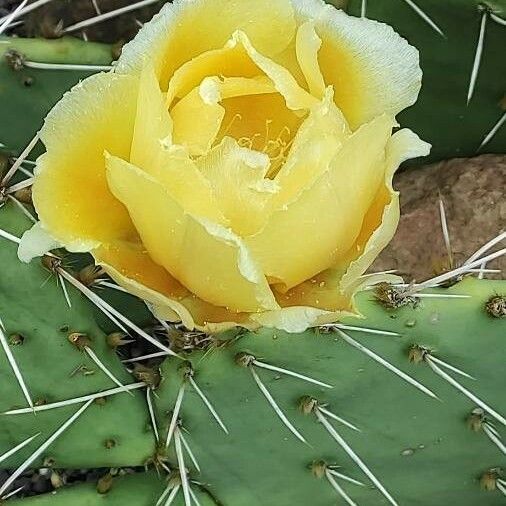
[0,202,153,468]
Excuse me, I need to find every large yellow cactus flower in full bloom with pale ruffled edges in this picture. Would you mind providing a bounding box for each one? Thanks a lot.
[20,0,429,332]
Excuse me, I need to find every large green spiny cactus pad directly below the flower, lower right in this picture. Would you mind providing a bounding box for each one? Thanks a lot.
[154,280,505,506]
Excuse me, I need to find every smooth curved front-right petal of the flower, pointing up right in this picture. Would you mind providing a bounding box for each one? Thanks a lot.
[246,115,394,289]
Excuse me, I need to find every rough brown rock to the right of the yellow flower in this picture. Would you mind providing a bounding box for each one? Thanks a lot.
[371,155,506,281]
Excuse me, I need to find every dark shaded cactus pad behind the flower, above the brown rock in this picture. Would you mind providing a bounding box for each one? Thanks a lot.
[348,0,506,160]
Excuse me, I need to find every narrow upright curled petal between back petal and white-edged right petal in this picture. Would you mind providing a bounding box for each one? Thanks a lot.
[296,21,325,98]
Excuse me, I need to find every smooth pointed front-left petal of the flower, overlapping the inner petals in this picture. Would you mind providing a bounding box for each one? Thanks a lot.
[107,157,277,311]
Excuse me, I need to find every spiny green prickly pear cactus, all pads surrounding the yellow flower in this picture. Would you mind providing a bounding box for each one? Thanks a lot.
[0,0,506,506]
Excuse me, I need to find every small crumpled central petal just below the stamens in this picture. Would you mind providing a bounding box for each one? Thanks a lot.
[197,137,277,236]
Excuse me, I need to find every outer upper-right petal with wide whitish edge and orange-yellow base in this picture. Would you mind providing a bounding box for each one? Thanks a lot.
[292,0,422,129]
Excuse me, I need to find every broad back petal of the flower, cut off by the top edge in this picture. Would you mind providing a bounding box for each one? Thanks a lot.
[117,0,295,89]
